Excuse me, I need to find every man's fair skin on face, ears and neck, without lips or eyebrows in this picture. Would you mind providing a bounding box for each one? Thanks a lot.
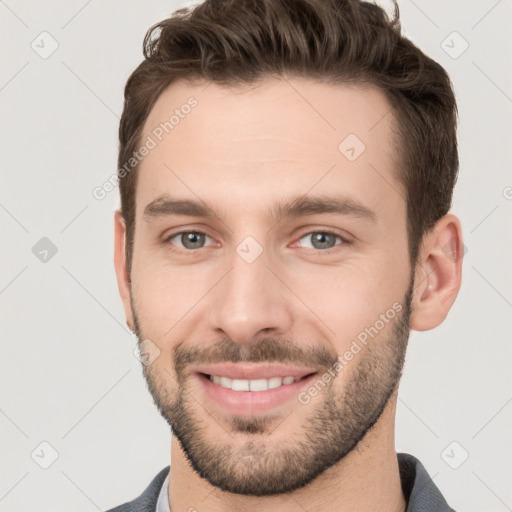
[115,77,462,512]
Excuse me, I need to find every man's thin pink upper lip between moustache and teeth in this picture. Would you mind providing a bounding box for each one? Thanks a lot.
[195,363,316,380]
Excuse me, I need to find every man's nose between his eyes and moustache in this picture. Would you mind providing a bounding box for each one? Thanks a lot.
[210,244,293,344]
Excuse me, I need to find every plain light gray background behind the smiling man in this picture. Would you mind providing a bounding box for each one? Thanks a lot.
[0,0,512,512]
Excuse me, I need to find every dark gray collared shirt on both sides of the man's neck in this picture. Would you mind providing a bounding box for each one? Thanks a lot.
[107,453,455,512]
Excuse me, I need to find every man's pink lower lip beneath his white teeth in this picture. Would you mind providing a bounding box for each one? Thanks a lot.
[198,373,317,414]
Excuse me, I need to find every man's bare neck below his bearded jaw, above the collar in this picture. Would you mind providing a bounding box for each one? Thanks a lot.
[169,395,407,512]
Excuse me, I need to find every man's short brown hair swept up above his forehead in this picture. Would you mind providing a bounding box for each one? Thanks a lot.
[118,0,459,269]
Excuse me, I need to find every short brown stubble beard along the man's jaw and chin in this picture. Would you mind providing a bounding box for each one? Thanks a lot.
[132,281,413,496]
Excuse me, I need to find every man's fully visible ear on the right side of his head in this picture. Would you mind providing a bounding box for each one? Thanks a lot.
[410,214,464,331]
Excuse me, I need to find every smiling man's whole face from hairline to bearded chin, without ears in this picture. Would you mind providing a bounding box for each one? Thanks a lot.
[126,79,412,495]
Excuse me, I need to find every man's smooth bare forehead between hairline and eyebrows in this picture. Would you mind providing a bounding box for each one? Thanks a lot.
[136,78,405,218]
